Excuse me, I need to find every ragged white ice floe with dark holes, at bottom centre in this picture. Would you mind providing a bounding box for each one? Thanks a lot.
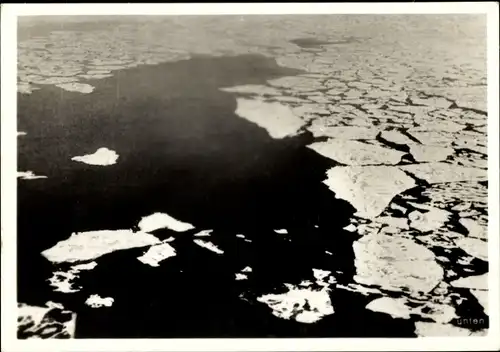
[257,284,334,324]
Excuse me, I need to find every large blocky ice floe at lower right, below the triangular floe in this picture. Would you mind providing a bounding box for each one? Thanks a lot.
[353,234,444,292]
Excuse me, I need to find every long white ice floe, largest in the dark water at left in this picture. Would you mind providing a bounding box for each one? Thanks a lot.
[42,230,160,263]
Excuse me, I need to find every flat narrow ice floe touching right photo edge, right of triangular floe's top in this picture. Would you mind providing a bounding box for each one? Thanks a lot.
[401,163,488,183]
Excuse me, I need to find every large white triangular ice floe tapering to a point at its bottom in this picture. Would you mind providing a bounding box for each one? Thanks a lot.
[323,166,416,218]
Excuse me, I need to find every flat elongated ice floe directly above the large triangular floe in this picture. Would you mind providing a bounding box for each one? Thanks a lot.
[308,139,405,166]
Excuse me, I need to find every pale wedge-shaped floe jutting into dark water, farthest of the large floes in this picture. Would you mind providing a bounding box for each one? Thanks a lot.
[235,98,305,139]
